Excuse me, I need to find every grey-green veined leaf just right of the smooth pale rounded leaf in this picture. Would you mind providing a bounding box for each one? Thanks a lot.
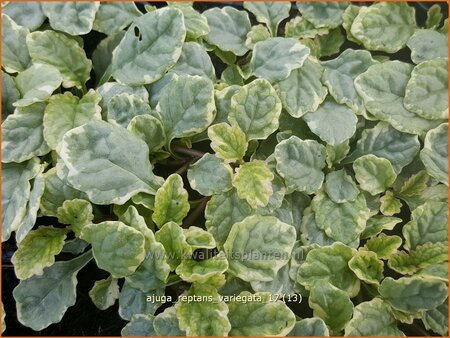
[344,122,420,174]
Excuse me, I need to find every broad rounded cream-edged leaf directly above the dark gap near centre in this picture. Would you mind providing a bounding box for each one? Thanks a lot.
[156,75,214,143]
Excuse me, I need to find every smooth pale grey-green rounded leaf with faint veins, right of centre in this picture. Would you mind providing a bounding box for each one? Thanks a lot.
[303,100,358,146]
